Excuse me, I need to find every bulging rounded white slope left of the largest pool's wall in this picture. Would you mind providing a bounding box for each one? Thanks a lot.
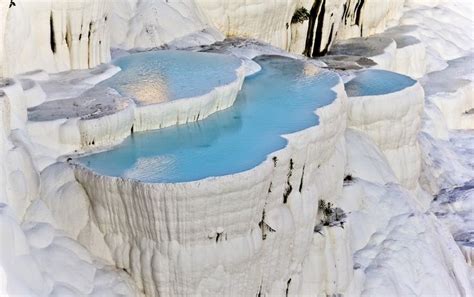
[0,80,137,296]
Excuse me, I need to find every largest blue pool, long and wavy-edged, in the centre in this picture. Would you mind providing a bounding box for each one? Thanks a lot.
[79,56,339,183]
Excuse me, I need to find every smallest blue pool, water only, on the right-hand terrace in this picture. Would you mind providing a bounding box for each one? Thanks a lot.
[344,69,416,97]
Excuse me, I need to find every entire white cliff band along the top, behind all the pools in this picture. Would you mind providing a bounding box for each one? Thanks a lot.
[0,0,412,75]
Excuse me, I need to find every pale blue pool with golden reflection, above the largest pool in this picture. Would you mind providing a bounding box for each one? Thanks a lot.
[98,51,241,104]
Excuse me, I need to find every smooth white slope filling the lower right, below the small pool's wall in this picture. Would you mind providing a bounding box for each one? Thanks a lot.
[338,130,473,296]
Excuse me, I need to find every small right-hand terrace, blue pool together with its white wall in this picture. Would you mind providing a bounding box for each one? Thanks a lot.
[346,70,424,190]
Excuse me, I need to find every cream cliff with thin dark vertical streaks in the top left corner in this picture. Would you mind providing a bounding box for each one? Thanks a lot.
[0,0,110,76]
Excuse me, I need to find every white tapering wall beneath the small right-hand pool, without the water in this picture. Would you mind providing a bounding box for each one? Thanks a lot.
[347,83,424,189]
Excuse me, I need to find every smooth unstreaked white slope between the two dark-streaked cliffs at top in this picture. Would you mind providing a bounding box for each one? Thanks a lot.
[111,0,223,49]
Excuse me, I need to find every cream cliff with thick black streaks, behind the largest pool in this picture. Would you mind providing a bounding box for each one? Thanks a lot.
[196,0,404,56]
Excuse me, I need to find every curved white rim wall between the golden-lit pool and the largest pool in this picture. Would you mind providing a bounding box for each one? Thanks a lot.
[27,54,246,155]
